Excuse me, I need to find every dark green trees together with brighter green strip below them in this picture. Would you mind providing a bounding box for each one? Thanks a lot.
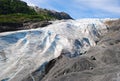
[0,0,55,23]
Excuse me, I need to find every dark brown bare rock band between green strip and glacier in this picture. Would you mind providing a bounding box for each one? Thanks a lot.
[0,21,52,32]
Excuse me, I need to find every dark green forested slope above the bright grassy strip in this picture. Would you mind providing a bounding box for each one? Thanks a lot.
[0,0,36,14]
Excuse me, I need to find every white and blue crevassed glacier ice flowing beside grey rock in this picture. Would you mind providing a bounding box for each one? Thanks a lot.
[0,19,115,81]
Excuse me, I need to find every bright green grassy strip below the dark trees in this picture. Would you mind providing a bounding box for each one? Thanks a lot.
[0,14,54,23]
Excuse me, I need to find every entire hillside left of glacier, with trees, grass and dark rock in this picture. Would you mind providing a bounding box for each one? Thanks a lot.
[0,0,72,32]
